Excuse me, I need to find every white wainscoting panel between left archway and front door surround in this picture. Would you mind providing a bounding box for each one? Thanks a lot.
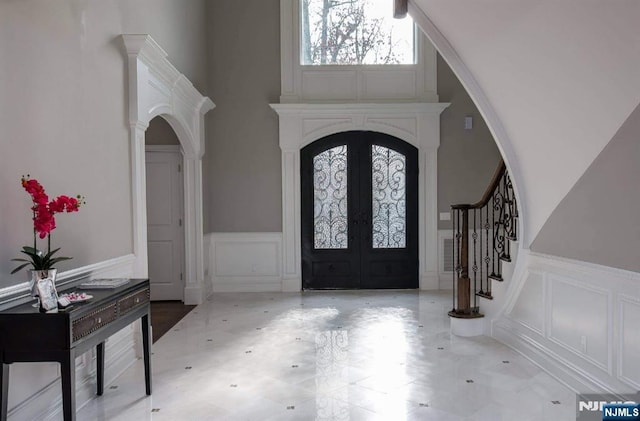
[206,232,282,292]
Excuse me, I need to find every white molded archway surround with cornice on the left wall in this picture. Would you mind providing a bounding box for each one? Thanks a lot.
[122,34,215,304]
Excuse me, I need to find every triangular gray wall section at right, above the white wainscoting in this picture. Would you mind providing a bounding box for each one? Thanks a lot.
[531,106,640,272]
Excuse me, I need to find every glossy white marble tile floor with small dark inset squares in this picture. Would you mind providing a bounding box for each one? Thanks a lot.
[78,291,576,421]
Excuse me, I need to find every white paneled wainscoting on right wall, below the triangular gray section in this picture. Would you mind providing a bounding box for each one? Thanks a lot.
[492,250,640,393]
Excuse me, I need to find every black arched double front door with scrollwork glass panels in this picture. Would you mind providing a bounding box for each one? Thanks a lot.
[300,131,418,289]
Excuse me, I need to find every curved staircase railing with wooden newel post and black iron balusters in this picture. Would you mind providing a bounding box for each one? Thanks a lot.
[449,161,518,327]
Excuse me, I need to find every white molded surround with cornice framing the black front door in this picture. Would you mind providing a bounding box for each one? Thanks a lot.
[271,103,449,291]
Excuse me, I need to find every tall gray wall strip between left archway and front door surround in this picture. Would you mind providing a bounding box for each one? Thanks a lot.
[204,0,282,232]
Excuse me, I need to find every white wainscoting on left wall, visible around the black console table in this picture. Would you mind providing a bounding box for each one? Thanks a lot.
[0,255,144,421]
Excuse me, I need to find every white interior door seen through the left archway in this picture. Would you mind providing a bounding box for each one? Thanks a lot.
[145,148,184,301]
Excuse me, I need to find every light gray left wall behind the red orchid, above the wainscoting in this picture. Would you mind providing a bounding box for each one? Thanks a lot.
[0,0,207,286]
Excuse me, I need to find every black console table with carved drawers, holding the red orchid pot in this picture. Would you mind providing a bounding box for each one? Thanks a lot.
[0,279,151,421]
